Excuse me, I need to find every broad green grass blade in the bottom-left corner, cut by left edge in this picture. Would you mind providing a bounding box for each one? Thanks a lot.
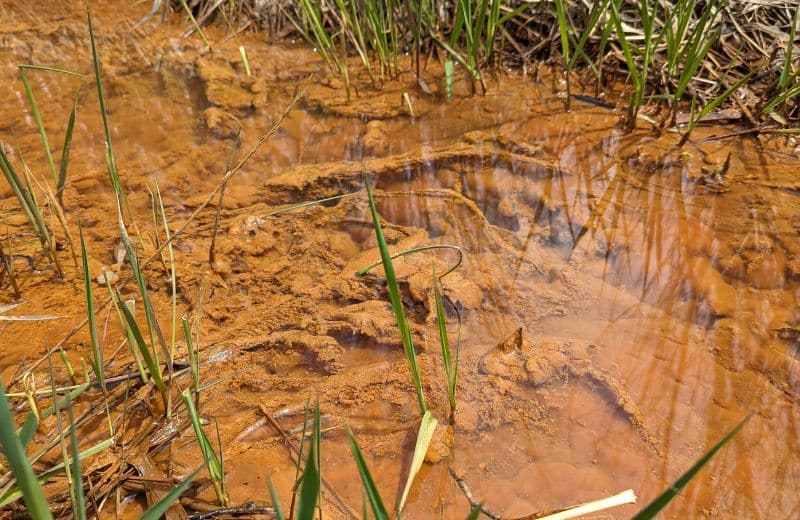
[0,379,53,520]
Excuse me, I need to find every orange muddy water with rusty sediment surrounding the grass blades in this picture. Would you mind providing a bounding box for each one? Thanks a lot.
[0,1,800,518]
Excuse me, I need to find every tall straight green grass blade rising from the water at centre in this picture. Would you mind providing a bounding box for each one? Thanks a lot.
[364,174,428,415]
